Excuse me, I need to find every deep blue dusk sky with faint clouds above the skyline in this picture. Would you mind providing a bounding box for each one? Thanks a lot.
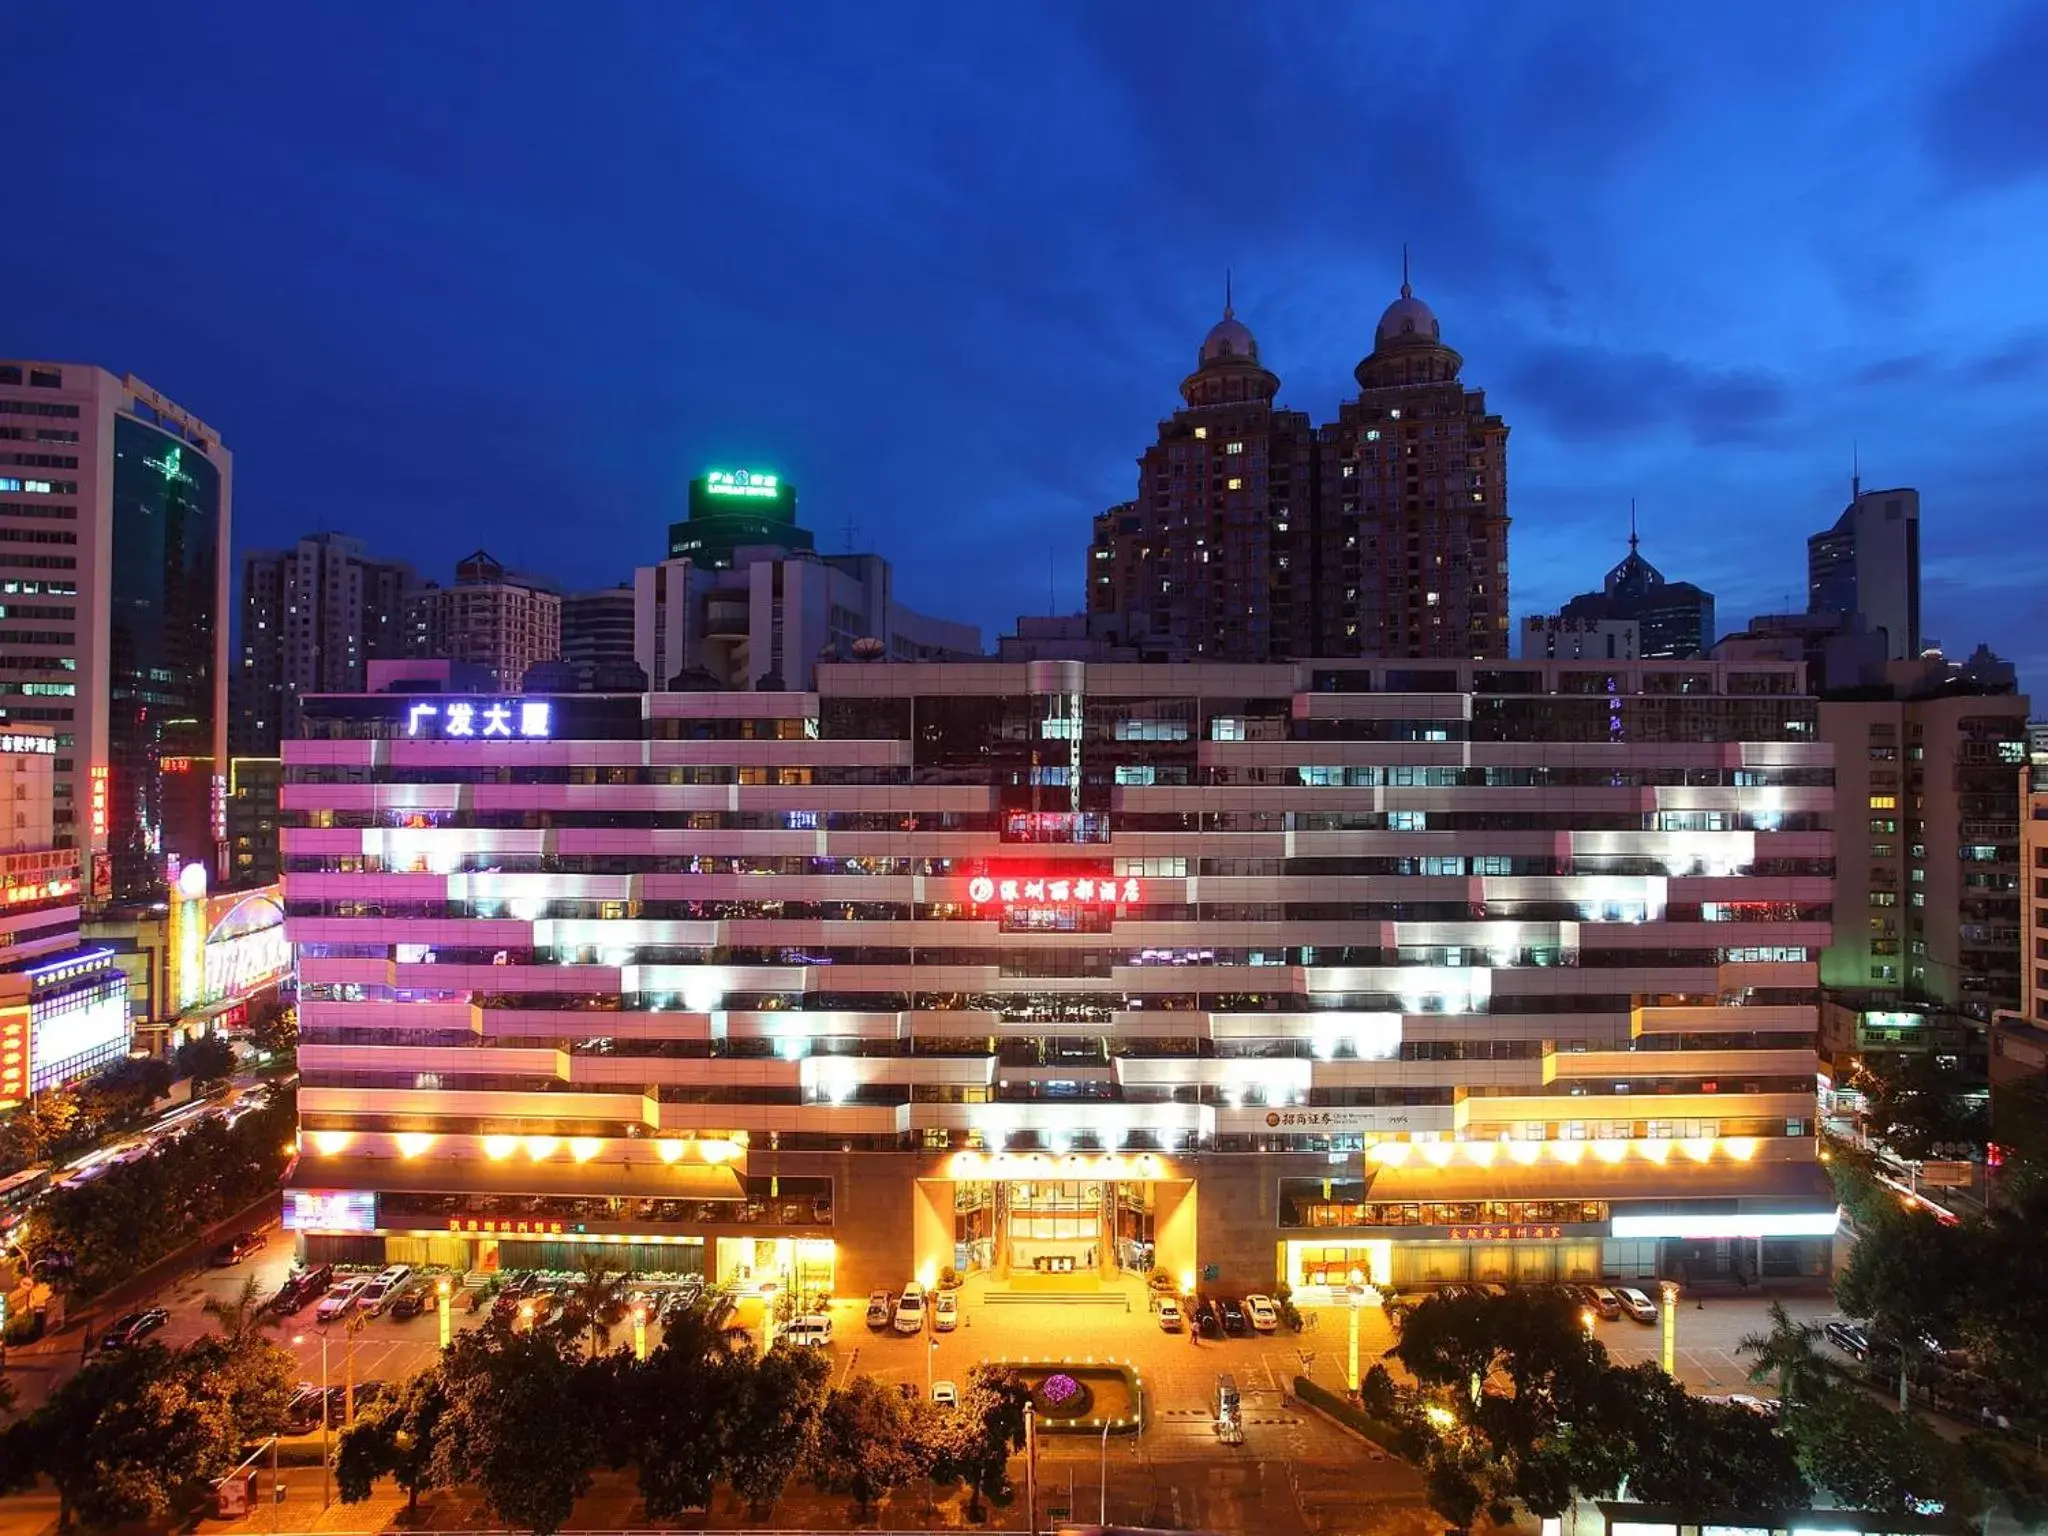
[12,0,2048,684]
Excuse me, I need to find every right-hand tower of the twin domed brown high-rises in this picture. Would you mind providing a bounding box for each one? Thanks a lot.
[1315,276,1507,659]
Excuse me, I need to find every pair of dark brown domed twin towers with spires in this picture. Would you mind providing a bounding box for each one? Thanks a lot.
[1087,262,1507,662]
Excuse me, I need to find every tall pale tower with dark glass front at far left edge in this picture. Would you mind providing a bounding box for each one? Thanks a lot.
[0,360,233,899]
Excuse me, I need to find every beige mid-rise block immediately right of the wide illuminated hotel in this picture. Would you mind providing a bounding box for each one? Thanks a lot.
[1821,684,2032,1020]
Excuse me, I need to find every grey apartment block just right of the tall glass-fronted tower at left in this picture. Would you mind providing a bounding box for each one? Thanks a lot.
[229,532,420,758]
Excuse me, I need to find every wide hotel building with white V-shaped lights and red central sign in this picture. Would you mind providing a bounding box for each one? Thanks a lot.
[283,662,1835,1298]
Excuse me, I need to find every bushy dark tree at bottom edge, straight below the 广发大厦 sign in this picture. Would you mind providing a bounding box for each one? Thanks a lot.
[432,1329,598,1536]
